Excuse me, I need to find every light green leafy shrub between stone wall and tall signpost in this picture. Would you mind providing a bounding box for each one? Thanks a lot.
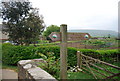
[39,52,60,78]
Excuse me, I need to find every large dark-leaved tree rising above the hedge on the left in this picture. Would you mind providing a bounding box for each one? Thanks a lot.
[2,1,45,45]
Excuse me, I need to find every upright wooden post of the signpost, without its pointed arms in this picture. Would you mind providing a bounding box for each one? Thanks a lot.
[60,24,67,79]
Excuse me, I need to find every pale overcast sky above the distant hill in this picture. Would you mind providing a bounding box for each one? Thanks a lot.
[30,0,120,31]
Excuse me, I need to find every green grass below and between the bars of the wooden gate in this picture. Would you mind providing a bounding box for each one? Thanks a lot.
[68,62,120,79]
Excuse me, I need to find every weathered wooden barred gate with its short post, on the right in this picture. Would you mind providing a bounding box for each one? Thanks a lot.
[77,51,120,79]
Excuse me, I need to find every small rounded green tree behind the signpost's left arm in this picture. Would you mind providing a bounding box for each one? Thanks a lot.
[43,25,60,40]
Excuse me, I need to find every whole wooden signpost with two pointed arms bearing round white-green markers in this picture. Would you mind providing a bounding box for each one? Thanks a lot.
[49,24,91,79]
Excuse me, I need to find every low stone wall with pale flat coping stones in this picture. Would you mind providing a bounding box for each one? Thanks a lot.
[18,59,57,81]
